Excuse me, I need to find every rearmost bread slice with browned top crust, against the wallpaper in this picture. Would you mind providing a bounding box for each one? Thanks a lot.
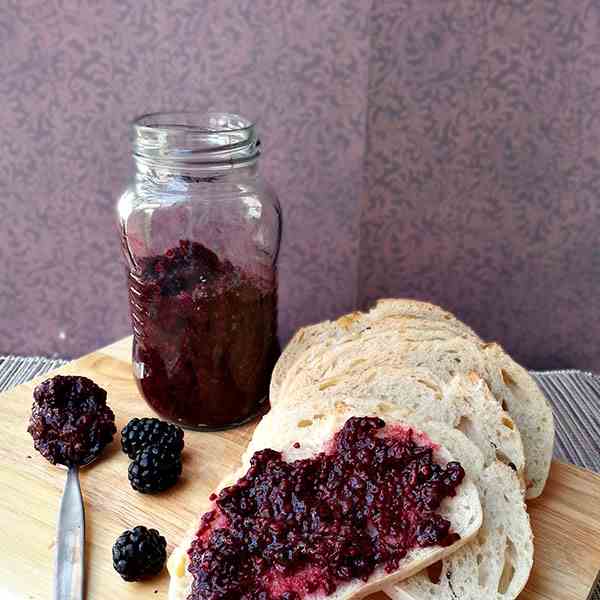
[270,299,479,404]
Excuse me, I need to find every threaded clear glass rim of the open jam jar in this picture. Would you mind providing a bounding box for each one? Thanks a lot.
[132,111,259,164]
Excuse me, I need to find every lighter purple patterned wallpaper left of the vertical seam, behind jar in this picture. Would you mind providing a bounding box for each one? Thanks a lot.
[0,0,369,356]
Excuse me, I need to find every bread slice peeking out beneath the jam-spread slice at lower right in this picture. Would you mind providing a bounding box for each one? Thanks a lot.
[384,463,533,600]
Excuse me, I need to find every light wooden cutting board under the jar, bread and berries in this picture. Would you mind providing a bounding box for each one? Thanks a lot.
[0,338,600,600]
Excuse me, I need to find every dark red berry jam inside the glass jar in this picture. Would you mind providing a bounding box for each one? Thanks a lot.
[130,240,278,428]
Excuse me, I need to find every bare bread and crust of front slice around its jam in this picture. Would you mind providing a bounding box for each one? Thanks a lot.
[168,404,482,600]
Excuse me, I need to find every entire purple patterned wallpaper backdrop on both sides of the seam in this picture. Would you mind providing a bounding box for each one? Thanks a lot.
[0,0,600,369]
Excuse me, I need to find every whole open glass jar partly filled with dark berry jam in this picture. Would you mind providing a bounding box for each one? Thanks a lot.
[118,112,281,429]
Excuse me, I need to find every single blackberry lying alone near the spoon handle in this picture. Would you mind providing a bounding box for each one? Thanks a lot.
[113,525,167,581]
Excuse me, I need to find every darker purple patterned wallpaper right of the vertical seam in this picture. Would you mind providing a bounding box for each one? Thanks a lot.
[359,0,600,369]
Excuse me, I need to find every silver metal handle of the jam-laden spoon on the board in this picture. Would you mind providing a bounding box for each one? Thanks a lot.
[54,467,85,600]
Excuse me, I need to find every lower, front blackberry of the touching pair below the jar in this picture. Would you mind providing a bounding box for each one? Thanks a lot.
[129,445,182,494]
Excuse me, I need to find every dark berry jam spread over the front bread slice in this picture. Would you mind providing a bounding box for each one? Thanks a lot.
[188,417,464,600]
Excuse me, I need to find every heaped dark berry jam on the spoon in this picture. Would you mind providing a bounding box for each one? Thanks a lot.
[27,375,117,466]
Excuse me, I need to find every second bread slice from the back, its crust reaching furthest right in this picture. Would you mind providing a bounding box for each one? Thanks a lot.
[279,329,554,498]
